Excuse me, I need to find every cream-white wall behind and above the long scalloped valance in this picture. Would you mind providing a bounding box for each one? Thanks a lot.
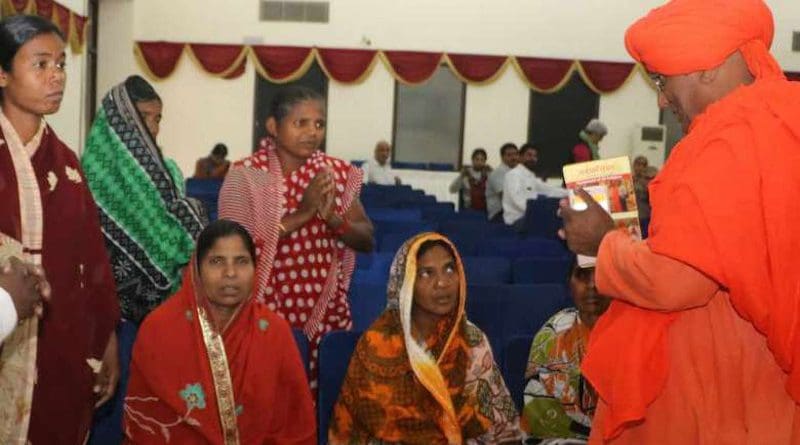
[98,0,800,174]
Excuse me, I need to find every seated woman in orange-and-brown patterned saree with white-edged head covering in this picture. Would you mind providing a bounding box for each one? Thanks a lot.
[328,233,522,445]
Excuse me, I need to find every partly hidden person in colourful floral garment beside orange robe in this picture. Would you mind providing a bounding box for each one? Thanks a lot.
[521,262,611,440]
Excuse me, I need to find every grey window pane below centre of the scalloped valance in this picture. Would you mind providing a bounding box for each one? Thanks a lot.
[392,66,466,169]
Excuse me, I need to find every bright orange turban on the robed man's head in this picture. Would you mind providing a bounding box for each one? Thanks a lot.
[625,0,780,77]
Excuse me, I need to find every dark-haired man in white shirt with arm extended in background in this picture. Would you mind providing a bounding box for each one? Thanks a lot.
[503,143,568,226]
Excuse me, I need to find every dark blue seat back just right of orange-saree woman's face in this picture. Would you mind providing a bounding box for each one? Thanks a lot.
[467,284,568,363]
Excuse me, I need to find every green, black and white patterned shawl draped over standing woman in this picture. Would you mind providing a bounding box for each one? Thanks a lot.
[81,83,207,323]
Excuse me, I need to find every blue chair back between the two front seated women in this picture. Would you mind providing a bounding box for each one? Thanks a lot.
[317,331,361,445]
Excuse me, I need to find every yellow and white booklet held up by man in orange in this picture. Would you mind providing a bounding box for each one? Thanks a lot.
[564,156,642,267]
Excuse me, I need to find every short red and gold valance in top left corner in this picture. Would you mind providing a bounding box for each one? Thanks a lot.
[0,0,88,53]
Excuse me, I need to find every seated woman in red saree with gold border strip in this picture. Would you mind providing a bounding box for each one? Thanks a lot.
[124,220,316,445]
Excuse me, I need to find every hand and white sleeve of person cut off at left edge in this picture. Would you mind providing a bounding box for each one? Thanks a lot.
[0,258,50,342]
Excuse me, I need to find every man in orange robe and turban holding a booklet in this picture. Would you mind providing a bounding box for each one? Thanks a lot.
[561,0,800,445]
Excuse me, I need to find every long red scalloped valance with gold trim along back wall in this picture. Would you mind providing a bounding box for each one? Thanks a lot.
[130,41,800,94]
